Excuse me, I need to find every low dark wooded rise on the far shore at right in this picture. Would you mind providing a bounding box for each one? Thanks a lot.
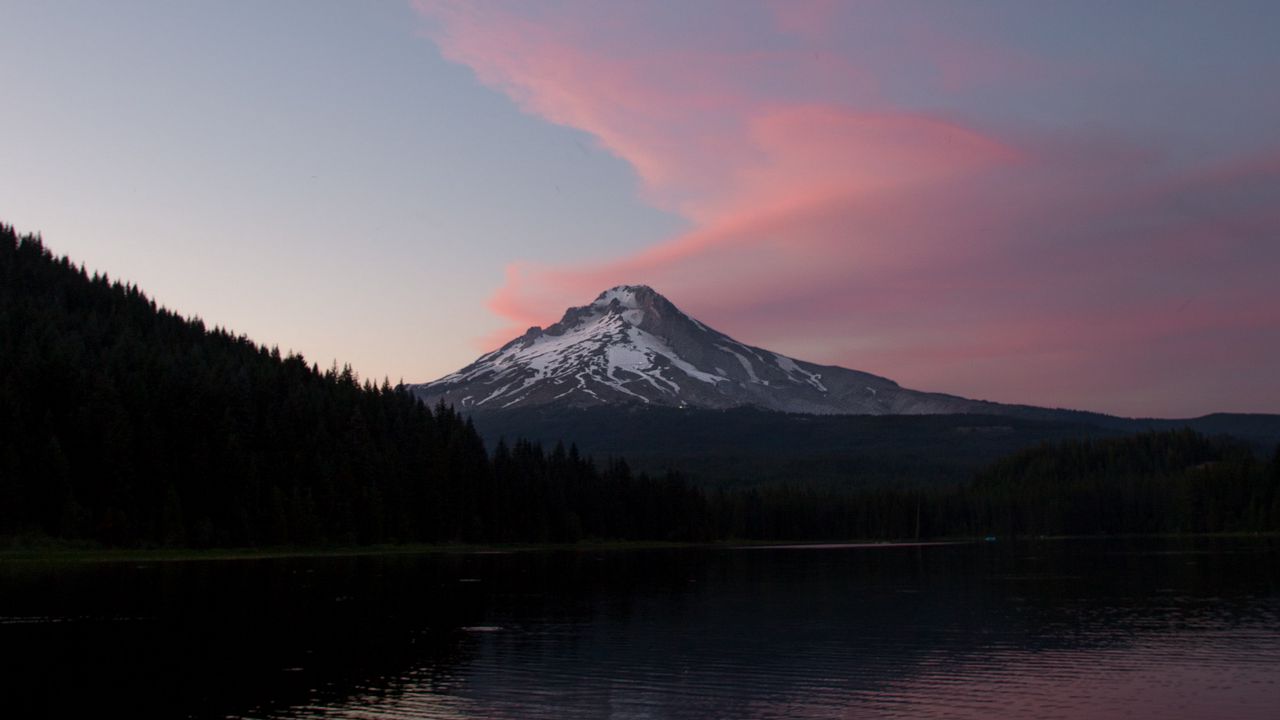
[710,430,1280,539]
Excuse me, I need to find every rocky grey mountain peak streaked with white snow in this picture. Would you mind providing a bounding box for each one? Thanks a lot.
[410,286,1016,415]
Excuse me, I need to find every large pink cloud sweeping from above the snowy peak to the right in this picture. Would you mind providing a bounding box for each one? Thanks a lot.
[419,1,1280,414]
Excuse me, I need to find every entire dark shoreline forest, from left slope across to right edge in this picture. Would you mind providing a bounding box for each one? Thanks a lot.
[0,225,1280,547]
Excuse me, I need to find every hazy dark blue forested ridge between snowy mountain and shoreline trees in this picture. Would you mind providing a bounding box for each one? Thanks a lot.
[471,405,1280,489]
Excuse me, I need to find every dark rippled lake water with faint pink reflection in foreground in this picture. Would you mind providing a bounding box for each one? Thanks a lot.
[0,539,1280,720]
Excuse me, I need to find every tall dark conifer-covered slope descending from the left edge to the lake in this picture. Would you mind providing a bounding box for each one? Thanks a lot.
[0,227,700,546]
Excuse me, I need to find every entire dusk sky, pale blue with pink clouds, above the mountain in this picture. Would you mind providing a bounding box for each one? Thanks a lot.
[0,0,1280,416]
